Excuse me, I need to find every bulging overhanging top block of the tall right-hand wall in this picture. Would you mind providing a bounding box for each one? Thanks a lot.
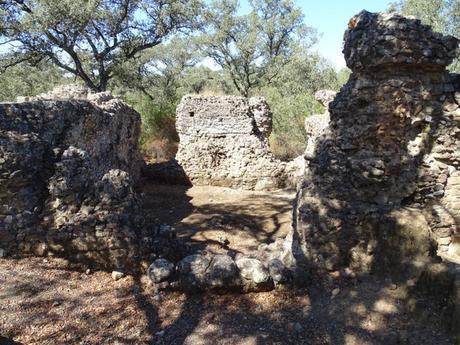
[343,11,458,71]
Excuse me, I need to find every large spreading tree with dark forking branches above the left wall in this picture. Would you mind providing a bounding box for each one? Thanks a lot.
[0,0,202,91]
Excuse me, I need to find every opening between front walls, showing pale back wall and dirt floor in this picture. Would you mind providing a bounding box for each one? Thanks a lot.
[142,95,296,255]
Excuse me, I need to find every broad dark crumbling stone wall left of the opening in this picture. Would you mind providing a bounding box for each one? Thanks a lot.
[0,86,148,268]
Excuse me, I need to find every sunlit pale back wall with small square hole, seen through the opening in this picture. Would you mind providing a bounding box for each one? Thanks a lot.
[176,96,295,190]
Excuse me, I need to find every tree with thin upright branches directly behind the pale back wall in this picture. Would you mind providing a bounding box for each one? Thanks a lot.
[201,0,316,97]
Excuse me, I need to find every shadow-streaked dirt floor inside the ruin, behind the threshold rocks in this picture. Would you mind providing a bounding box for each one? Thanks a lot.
[142,183,295,254]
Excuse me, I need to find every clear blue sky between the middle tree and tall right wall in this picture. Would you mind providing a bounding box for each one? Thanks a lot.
[241,0,392,69]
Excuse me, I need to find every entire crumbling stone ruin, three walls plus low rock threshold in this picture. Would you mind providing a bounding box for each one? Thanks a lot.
[0,11,460,291]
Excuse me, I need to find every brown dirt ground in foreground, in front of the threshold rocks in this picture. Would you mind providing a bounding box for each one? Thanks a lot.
[0,258,455,345]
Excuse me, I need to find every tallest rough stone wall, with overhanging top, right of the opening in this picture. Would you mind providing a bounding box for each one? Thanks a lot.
[294,11,460,271]
